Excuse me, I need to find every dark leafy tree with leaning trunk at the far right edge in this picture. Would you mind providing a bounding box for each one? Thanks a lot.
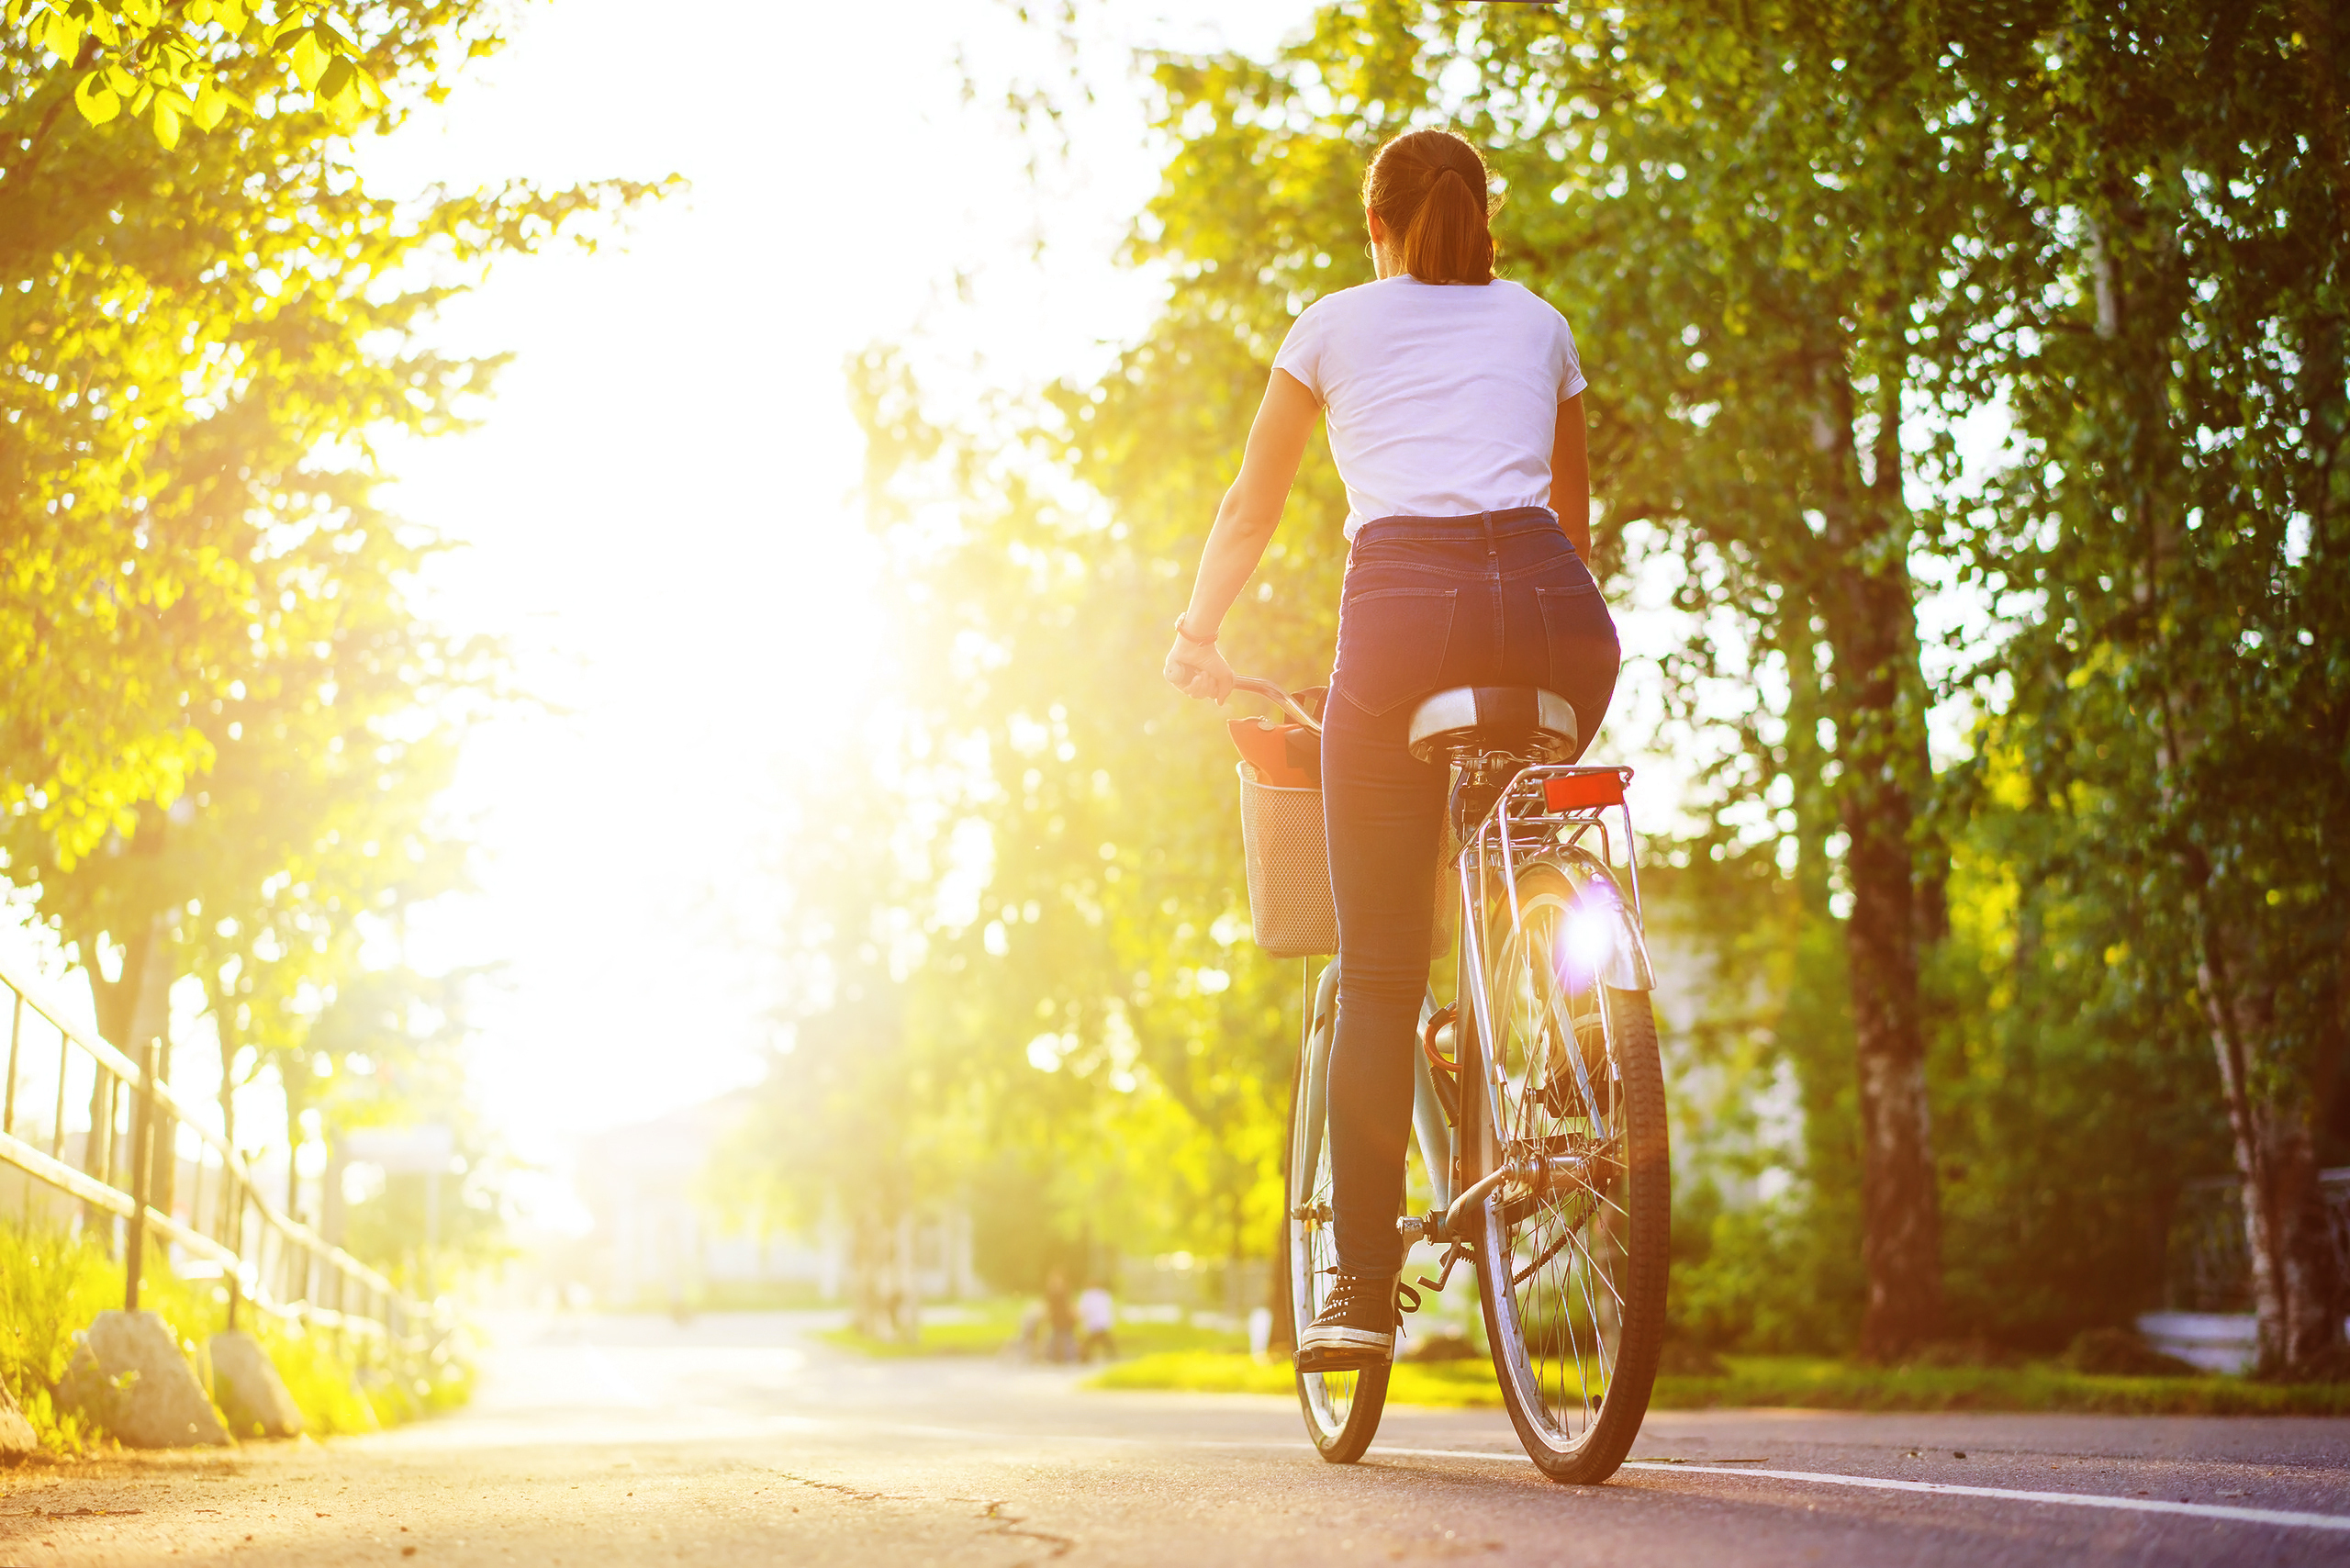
[1974,3,2350,1368]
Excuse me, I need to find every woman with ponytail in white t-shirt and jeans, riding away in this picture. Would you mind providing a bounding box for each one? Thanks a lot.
[1166,131,1617,1372]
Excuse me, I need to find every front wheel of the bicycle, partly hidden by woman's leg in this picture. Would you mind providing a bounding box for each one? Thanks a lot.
[1281,961,1389,1464]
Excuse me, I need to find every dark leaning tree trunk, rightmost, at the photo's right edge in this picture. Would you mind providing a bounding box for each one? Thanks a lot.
[2195,917,2345,1375]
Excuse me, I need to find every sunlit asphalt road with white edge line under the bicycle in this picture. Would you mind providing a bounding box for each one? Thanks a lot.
[0,1314,2350,1568]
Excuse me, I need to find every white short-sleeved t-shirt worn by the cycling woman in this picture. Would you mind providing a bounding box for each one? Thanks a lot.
[1274,277,1586,538]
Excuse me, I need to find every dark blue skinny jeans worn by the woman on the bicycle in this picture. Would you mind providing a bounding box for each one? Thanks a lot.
[1321,508,1619,1274]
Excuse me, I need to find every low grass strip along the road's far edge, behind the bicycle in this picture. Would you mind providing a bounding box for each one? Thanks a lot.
[1086,1351,2350,1416]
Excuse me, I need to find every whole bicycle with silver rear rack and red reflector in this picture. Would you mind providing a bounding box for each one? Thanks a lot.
[1234,679,1671,1485]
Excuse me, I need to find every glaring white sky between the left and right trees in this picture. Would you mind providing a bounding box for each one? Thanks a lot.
[342,0,1309,1213]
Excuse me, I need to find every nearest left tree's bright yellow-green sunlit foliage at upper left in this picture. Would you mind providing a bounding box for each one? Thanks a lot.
[0,0,654,865]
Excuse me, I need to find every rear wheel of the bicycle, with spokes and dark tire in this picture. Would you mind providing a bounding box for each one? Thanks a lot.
[1464,860,1673,1485]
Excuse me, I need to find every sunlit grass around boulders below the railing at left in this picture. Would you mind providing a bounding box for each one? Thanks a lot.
[0,1225,473,1455]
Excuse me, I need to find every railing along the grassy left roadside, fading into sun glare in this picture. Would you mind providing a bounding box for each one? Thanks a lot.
[0,964,432,1347]
